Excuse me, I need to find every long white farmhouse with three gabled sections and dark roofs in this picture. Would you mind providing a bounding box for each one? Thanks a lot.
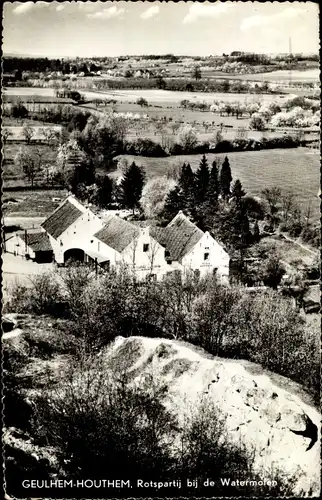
[42,196,229,282]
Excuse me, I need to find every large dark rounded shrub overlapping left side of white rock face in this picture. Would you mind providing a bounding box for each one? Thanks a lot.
[34,357,175,479]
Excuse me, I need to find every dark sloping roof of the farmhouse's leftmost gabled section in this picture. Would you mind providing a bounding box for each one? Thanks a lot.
[41,199,83,239]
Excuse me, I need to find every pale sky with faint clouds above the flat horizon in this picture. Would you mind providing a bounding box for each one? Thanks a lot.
[2,1,319,57]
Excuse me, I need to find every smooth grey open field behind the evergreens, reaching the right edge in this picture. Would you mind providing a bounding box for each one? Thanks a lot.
[111,148,320,219]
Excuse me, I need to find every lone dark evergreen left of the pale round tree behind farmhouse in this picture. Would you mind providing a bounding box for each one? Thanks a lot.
[120,162,145,213]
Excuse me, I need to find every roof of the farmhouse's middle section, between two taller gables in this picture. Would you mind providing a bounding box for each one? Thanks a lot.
[94,215,140,252]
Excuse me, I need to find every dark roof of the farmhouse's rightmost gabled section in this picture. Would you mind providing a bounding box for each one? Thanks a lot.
[150,212,204,261]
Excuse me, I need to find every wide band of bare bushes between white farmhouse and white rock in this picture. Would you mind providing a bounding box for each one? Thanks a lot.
[6,268,319,400]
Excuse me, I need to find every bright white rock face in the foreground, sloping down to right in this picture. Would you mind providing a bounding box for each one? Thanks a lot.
[104,337,320,496]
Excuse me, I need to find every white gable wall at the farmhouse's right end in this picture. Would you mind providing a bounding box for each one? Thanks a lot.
[182,232,229,282]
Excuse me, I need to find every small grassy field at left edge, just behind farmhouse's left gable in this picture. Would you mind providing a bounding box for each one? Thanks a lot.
[2,189,67,217]
